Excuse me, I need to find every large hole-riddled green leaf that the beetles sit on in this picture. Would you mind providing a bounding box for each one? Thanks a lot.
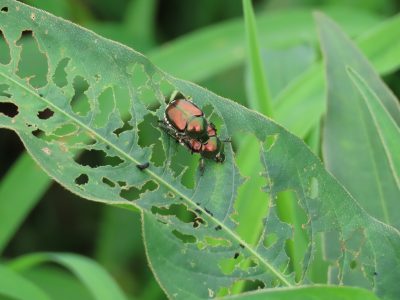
[0,0,400,299]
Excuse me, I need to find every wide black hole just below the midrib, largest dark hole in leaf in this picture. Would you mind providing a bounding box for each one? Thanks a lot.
[76,149,124,168]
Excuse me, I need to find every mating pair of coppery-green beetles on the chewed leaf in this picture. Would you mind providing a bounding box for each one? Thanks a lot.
[159,99,225,173]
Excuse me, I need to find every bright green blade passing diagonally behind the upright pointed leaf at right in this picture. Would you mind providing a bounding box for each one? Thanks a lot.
[274,15,400,137]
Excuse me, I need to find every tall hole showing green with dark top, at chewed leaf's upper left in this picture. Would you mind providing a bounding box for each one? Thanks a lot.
[17,30,48,88]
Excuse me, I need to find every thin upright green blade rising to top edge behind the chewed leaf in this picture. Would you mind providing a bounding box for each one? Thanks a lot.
[242,0,273,117]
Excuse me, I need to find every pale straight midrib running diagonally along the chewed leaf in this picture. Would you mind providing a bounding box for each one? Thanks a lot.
[0,71,292,287]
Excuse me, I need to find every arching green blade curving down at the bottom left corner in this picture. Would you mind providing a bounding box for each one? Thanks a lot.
[9,253,126,300]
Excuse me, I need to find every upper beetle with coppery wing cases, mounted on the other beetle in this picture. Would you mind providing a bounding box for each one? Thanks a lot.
[163,99,208,142]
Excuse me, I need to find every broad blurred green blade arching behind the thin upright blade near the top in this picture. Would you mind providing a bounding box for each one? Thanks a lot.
[148,7,382,82]
